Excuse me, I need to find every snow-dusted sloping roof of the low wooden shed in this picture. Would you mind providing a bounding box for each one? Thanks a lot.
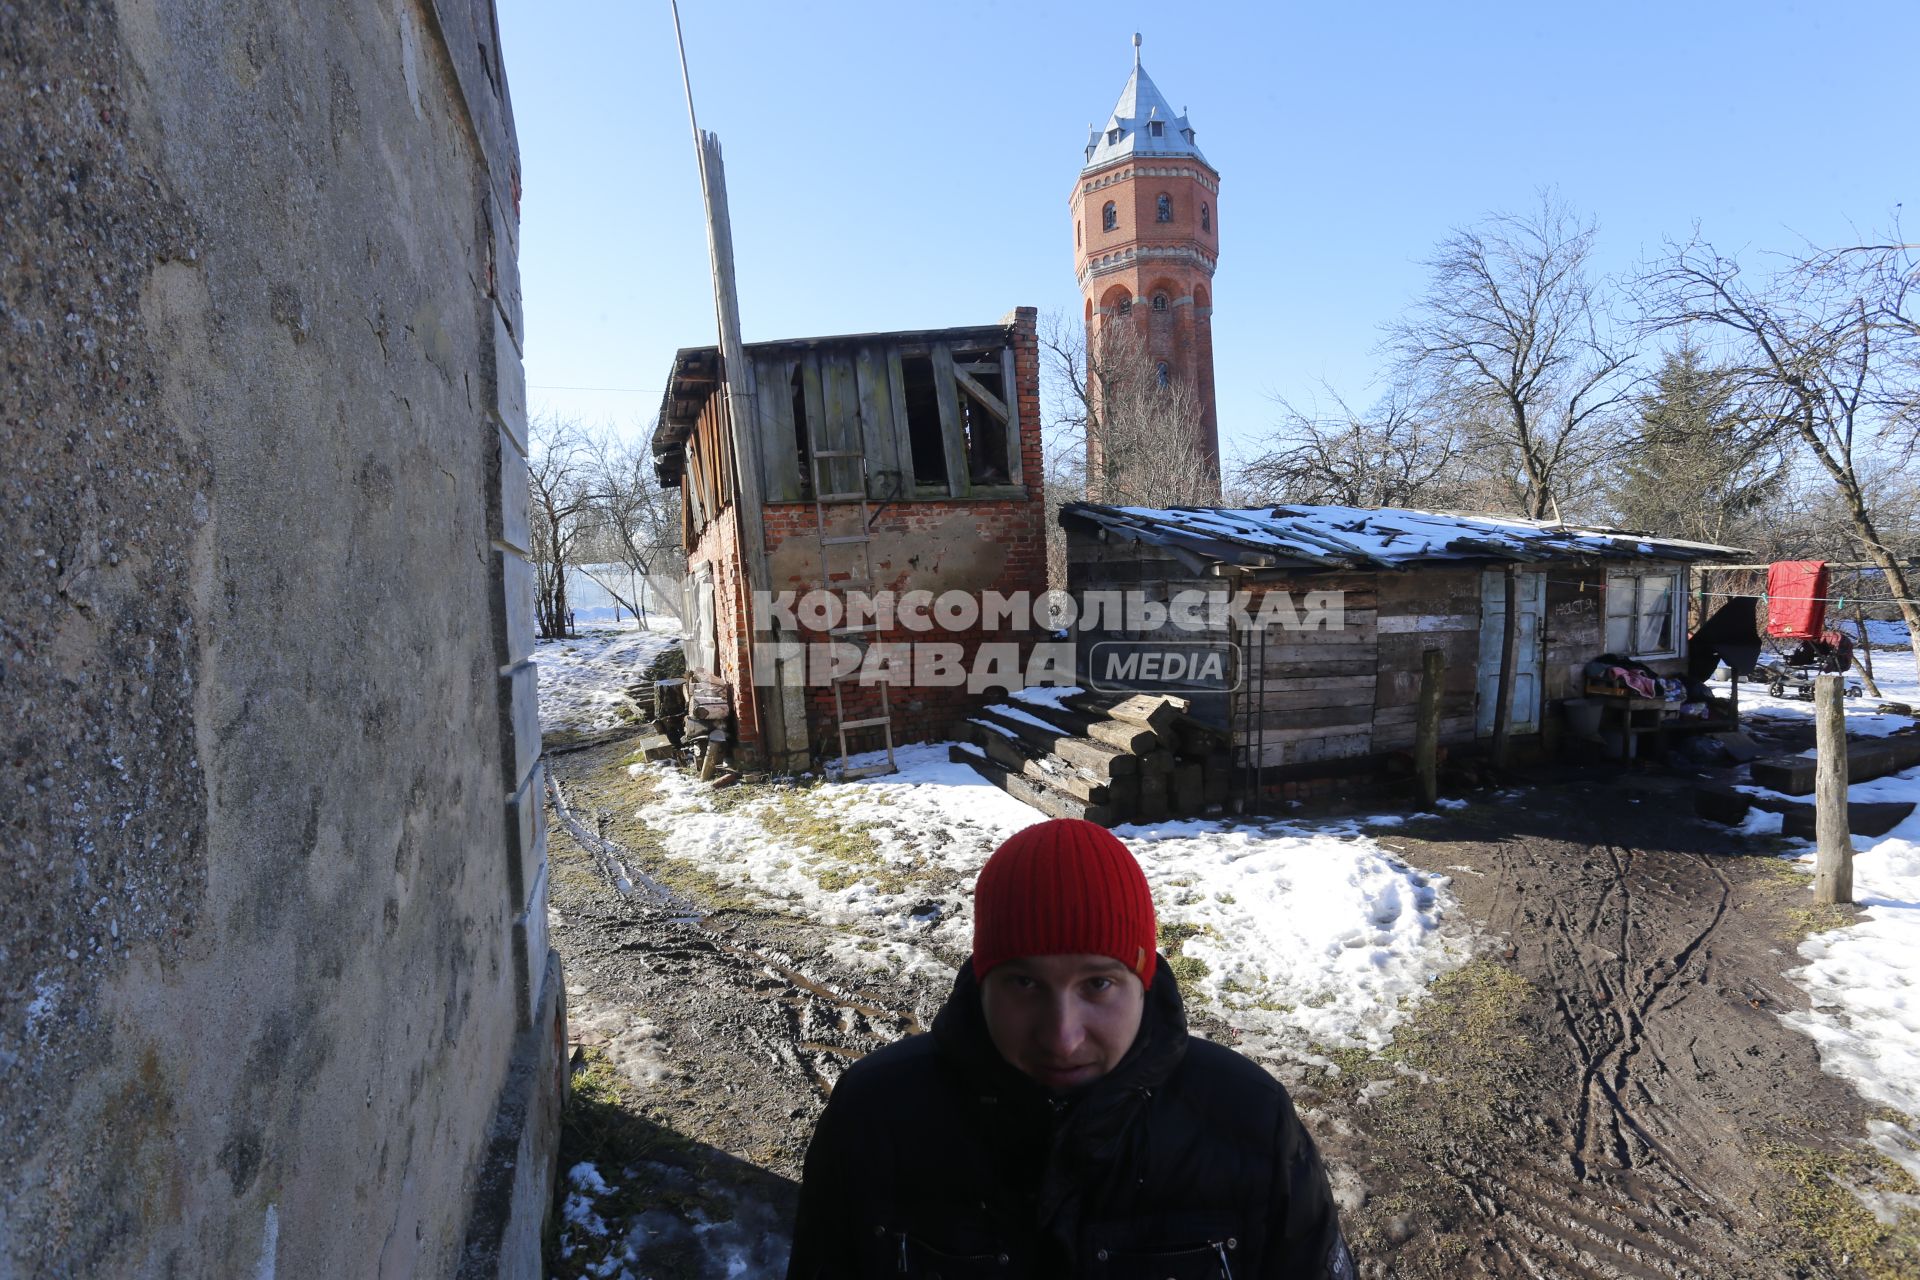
[1060,503,1747,568]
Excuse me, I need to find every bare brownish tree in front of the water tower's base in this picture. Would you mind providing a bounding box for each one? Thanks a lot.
[1041,317,1219,507]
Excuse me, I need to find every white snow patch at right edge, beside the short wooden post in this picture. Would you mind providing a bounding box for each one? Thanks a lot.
[1784,770,1920,1119]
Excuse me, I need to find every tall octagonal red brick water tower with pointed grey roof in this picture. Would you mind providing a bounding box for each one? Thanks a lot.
[1071,35,1219,501]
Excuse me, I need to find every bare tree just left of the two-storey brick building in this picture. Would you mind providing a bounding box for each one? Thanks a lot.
[582,426,687,622]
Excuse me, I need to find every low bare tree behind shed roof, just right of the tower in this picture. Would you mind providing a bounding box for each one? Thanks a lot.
[1235,388,1461,507]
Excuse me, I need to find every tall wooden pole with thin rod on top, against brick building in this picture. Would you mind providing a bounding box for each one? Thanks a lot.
[672,2,795,770]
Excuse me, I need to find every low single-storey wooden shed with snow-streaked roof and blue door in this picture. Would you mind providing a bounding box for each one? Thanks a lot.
[1060,503,1743,794]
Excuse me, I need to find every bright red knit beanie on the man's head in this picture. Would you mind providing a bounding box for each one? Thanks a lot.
[973,818,1156,986]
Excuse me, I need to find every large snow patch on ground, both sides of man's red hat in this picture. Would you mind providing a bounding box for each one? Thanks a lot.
[630,745,1465,1055]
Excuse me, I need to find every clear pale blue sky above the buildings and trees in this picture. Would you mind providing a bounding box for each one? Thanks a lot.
[499,0,1920,466]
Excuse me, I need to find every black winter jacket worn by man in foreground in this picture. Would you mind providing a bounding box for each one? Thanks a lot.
[787,961,1354,1280]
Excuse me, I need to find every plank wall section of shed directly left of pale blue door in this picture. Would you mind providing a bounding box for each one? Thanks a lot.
[1373,566,1480,750]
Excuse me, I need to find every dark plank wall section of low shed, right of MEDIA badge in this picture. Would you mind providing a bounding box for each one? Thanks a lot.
[1231,574,1380,768]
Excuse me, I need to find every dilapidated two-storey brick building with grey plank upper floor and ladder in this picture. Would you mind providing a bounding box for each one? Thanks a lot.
[653,307,1046,764]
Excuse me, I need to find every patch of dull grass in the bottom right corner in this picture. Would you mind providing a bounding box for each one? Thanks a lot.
[1759,1142,1920,1280]
